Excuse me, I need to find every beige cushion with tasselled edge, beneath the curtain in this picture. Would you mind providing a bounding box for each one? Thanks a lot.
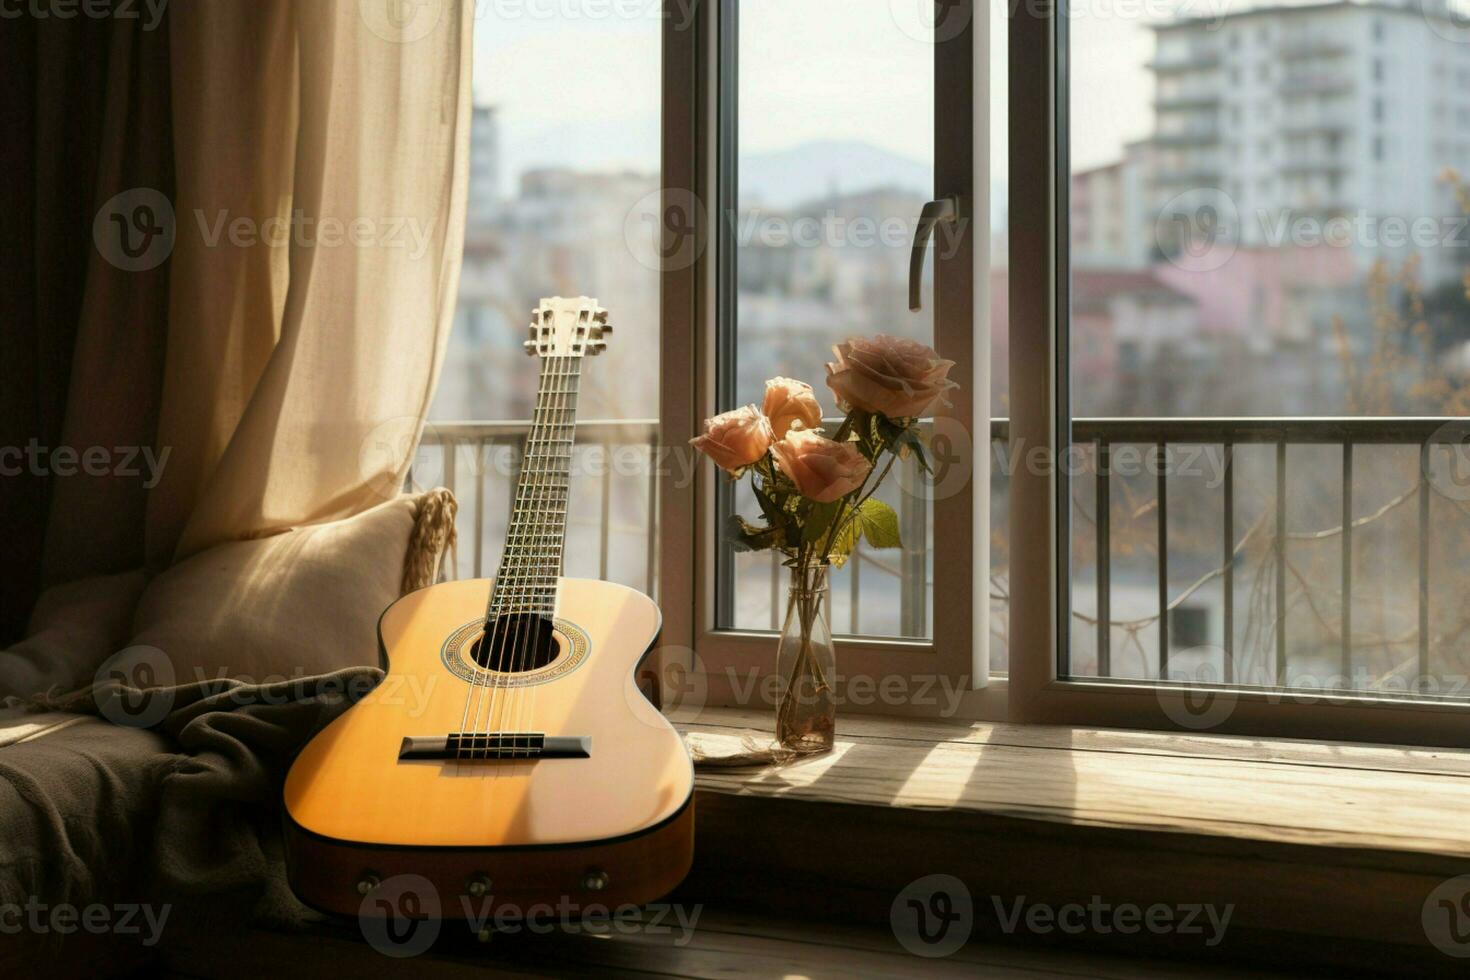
[123,489,454,686]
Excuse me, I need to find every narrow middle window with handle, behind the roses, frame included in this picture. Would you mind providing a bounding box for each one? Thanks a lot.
[663,0,1004,708]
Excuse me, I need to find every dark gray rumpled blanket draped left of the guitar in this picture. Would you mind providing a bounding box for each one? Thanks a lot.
[0,667,382,976]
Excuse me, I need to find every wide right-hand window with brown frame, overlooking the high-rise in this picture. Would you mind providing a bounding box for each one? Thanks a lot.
[1010,4,1470,743]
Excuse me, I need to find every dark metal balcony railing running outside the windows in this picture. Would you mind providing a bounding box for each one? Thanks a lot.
[415,417,1470,686]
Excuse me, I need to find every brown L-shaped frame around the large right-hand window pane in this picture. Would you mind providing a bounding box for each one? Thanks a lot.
[1008,0,1470,746]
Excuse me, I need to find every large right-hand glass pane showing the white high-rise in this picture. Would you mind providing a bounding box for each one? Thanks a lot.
[1061,0,1470,696]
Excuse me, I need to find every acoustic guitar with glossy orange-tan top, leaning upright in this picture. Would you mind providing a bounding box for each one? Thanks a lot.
[285,297,694,920]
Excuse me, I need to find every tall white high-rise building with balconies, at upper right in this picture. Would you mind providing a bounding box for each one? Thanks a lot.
[1144,0,1470,282]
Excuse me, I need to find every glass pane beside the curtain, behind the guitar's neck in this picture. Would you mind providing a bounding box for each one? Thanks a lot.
[415,3,663,592]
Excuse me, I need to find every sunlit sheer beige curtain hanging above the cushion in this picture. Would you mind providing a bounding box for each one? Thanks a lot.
[147,0,473,566]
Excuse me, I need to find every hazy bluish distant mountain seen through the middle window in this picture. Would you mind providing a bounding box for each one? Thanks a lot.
[739,140,933,207]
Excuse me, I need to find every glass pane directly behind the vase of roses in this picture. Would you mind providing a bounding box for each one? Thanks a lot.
[719,0,935,638]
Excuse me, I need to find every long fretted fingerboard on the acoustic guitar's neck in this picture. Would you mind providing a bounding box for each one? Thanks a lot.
[485,357,582,621]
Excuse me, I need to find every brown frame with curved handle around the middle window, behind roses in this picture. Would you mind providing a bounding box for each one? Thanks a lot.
[659,0,1005,717]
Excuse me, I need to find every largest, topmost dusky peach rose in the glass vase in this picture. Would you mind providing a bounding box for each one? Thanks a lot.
[828,334,956,419]
